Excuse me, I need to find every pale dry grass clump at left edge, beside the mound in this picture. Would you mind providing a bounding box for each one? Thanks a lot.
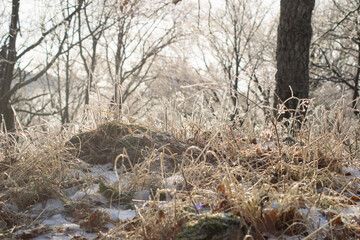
[0,127,79,214]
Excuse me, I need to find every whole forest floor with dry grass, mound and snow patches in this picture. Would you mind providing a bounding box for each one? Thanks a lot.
[0,111,360,240]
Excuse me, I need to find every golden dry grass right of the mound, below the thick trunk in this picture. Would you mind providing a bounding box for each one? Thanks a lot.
[100,99,360,239]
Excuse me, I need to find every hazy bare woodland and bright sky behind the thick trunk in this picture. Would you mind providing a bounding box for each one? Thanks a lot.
[0,0,360,129]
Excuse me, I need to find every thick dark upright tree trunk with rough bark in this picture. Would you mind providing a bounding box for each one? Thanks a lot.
[274,0,315,120]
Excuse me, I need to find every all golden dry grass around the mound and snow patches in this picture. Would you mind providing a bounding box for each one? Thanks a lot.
[0,98,360,239]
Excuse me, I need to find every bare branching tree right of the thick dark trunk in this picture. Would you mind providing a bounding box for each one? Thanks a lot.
[311,0,360,115]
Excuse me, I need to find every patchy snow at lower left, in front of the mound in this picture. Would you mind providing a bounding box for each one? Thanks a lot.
[14,161,136,240]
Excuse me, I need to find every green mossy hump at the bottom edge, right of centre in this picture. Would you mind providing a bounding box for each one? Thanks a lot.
[177,214,244,240]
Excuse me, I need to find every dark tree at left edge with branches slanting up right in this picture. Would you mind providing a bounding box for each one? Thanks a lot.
[0,0,84,130]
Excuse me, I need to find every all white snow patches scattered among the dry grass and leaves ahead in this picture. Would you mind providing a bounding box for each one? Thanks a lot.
[14,159,360,240]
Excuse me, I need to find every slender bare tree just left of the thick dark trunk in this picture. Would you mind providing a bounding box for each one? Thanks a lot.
[201,0,273,123]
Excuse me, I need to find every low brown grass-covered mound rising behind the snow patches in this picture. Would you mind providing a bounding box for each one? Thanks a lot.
[67,121,190,171]
